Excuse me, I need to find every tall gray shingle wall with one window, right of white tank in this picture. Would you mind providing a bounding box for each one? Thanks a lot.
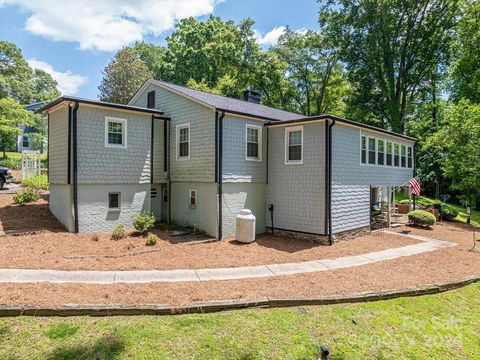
[266,122,325,234]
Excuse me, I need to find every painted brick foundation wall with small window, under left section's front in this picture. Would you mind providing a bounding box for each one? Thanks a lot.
[78,184,150,232]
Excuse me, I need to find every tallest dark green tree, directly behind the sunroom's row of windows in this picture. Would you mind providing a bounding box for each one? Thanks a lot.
[319,0,458,132]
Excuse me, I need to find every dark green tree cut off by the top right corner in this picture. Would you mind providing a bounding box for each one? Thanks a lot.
[451,0,480,103]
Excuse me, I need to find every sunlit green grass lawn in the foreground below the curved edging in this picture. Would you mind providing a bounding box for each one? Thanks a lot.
[0,283,480,360]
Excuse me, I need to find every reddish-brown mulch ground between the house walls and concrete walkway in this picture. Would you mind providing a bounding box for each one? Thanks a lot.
[0,191,417,270]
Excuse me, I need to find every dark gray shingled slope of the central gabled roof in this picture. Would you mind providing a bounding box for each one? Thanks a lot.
[152,80,305,120]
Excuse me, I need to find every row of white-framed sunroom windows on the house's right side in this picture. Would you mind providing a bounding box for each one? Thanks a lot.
[360,135,413,169]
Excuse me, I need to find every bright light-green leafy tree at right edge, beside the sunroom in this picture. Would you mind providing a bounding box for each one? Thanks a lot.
[427,100,480,215]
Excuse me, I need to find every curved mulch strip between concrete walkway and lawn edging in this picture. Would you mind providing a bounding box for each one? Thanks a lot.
[0,224,480,305]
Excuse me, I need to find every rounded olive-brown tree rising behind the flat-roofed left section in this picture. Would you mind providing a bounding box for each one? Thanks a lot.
[98,47,152,104]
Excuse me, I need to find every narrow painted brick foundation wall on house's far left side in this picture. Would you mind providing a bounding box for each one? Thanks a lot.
[49,184,74,231]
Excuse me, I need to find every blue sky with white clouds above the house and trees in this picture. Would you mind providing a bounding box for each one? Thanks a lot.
[0,0,319,98]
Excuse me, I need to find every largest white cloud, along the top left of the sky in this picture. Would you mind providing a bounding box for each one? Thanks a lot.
[0,0,219,51]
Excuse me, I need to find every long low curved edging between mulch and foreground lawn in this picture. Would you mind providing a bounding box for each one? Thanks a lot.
[0,275,480,317]
